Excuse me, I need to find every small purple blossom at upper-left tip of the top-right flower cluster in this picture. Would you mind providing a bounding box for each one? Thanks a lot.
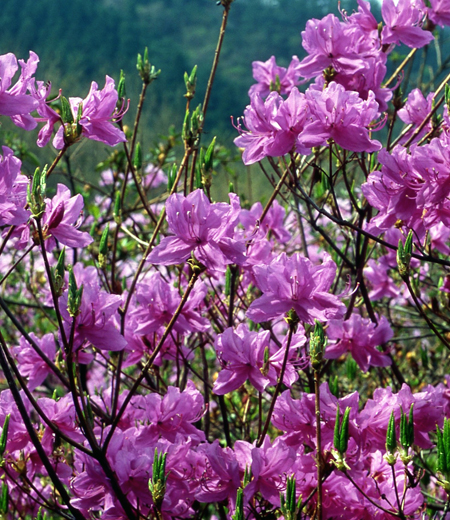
[248,56,300,97]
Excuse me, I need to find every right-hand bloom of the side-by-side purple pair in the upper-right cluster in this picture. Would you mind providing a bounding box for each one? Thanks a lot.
[298,81,381,152]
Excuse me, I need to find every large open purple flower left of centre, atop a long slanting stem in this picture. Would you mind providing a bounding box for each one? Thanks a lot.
[148,190,245,271]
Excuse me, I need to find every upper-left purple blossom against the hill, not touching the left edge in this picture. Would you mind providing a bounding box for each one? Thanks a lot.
[53,76,127,150]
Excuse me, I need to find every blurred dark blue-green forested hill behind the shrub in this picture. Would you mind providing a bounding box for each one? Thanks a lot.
[0,0,354,141]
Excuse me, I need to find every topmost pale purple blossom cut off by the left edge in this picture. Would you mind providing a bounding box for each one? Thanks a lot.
[0,52,39,126]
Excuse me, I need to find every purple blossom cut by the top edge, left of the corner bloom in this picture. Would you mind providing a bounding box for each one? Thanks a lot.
[381,0,434,48]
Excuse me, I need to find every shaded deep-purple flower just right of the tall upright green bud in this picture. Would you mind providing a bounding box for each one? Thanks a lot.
[325,314,394,372]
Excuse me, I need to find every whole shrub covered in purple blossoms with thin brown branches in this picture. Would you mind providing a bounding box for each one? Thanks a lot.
[0,0,450,520]
